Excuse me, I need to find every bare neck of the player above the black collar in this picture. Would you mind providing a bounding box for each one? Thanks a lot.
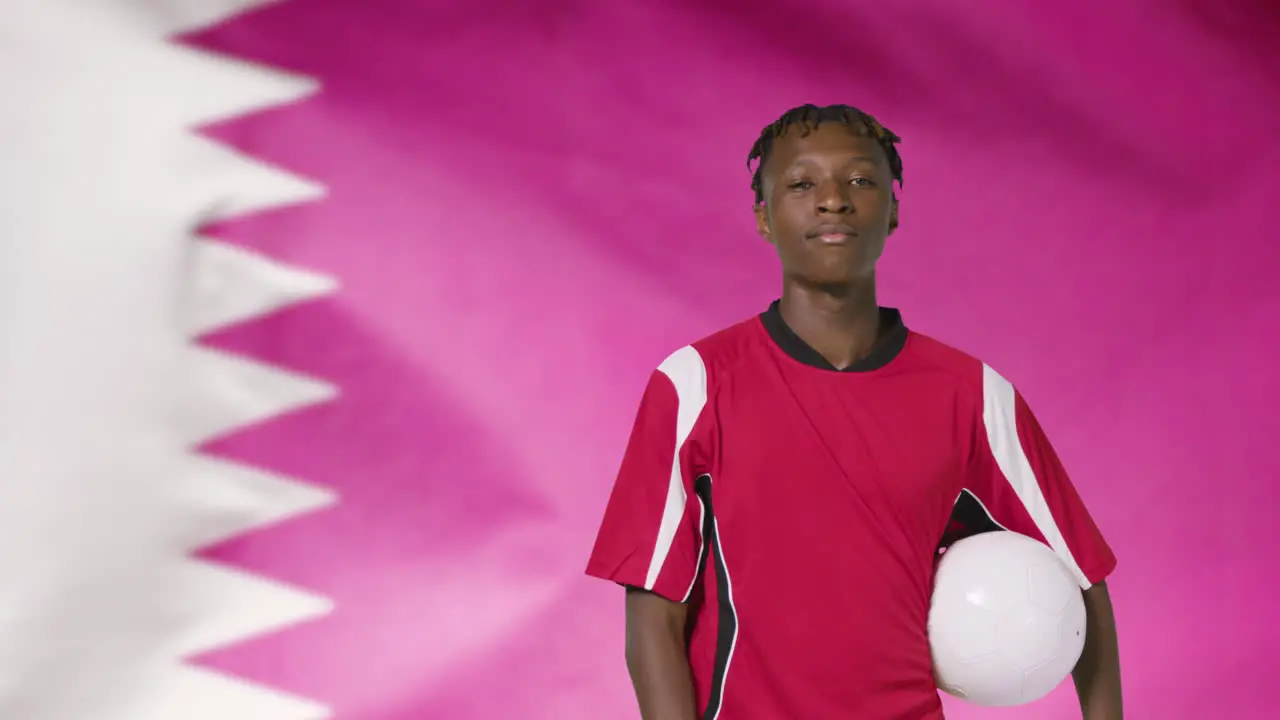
[778,271,881,368]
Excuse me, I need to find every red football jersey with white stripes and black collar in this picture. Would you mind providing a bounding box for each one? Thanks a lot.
[588,304,1115,720]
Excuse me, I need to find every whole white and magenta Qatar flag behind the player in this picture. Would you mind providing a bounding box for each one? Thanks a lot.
[0,0,1280,720]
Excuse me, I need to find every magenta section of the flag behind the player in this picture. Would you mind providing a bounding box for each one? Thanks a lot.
[180,0,1280,720]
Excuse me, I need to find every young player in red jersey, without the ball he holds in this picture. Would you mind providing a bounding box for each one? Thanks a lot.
[588,105,1121,720]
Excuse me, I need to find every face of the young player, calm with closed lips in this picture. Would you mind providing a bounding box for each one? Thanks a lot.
[755,123,896,286]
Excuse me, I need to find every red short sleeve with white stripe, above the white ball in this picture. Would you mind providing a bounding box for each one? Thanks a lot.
[966,366,1116,589]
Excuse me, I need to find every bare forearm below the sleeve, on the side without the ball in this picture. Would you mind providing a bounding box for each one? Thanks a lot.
[626,588,698,720]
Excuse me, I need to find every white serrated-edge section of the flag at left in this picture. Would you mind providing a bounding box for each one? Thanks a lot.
[0,0,337,720]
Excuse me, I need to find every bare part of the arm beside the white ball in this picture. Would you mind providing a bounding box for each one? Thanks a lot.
[1071,582,1124,720]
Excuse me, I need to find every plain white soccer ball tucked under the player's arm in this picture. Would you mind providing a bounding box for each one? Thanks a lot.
[928,530,1084,707]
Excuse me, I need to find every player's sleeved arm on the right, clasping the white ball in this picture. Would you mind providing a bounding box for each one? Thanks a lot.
[969,366,1123,720]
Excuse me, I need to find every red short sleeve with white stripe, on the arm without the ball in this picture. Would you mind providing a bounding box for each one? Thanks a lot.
[586,347,707,602]
